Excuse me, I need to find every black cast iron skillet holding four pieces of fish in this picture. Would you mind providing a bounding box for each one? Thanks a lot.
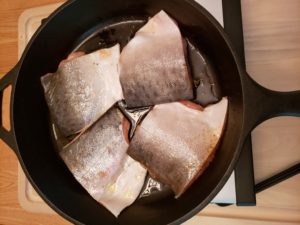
[0,0,300,225]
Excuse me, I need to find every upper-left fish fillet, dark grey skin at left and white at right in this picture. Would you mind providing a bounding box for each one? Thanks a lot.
[41,44,123,137]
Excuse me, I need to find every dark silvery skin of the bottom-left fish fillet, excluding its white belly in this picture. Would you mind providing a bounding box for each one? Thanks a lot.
[59,107,128,199]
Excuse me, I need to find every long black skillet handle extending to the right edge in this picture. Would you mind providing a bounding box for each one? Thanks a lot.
[243,74,300,137]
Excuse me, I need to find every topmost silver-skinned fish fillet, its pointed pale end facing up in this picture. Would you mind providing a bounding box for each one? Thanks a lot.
[120,11,193,108]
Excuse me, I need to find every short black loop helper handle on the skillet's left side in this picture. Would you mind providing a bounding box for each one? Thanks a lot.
[0,65,19,151]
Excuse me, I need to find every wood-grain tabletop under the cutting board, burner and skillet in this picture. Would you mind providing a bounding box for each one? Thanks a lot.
[0,0,300,225]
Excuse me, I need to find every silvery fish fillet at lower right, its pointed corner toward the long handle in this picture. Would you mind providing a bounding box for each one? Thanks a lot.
[128,98,227,198]
